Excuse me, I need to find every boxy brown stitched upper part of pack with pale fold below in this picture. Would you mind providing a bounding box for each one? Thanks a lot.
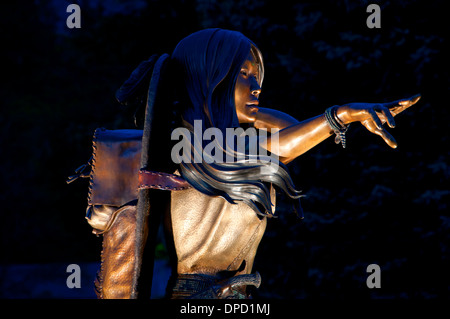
[86,128,142,234]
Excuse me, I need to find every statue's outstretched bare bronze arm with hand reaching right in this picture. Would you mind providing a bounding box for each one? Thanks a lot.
[255,95,420,164]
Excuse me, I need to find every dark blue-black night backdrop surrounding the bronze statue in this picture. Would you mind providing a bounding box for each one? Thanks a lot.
[0,0,450,300]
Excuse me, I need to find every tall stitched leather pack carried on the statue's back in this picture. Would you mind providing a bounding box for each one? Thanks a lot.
[68,54,185,298]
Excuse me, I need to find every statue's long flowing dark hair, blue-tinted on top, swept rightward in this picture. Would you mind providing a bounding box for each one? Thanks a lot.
[168,29,302,216]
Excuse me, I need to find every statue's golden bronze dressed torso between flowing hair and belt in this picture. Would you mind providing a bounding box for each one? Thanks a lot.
[170,187,275,275]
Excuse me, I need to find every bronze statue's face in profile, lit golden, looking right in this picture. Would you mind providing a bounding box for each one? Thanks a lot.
[234,53,261,123]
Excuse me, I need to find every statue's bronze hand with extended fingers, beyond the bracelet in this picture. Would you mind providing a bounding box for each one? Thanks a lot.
[337,94,421,148]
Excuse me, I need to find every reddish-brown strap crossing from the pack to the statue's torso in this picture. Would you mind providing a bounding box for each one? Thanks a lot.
[139,170,191,191]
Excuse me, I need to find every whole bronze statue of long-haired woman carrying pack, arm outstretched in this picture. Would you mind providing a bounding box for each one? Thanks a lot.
[68,29,420,299]
